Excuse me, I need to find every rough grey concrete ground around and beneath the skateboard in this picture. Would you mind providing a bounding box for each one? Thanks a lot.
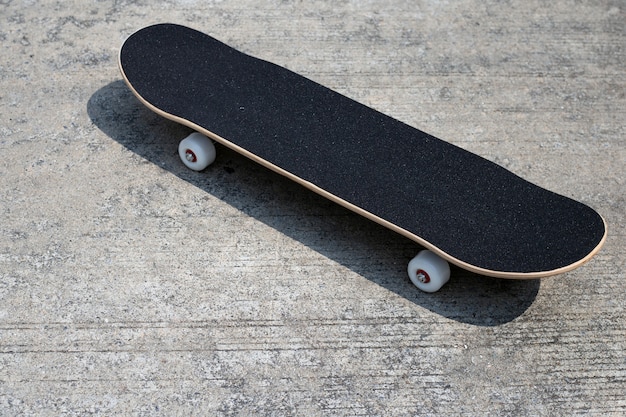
[0,0,626,416]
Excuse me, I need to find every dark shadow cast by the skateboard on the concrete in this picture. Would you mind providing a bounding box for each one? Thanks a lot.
[87,80,540,326]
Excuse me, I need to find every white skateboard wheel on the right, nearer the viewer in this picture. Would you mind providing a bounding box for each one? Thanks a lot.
[407,250,450,292]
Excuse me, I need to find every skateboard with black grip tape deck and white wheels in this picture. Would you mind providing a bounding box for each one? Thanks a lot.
[119,24,607,292]
